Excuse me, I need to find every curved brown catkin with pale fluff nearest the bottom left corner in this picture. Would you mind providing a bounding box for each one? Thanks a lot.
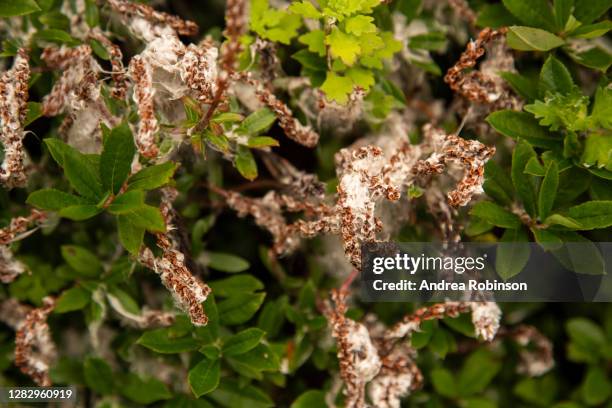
[15,297,56,387]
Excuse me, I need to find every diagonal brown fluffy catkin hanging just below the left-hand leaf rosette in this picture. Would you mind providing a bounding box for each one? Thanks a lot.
[139,187,210,326]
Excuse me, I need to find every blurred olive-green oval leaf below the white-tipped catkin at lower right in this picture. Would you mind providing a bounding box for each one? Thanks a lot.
[457,349,501,396]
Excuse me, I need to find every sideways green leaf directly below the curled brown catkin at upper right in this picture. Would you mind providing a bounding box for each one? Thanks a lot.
[486,110,561,149]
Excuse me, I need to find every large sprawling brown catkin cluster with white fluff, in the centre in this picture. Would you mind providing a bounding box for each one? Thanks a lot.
[219,125,495,269]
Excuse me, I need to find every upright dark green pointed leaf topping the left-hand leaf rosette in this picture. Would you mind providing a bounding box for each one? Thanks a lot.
[100,122,136,194]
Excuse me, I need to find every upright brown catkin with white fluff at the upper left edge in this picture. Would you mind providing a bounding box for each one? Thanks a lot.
[0,49,30,188]
